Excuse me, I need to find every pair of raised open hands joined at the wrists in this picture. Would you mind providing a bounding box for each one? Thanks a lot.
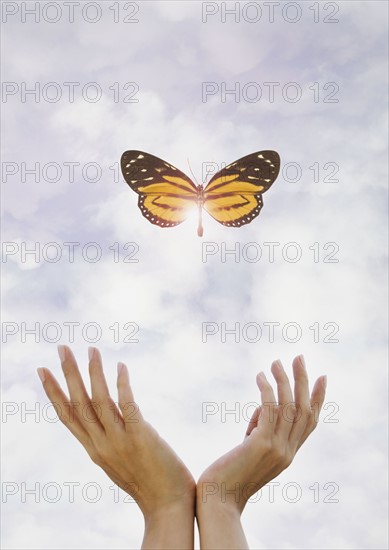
[38,346,326,549]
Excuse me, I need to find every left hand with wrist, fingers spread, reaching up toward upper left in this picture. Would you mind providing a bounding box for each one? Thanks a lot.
[38,346,196,548]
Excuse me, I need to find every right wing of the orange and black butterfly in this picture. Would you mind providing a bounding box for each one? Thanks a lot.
[204,151,280,227]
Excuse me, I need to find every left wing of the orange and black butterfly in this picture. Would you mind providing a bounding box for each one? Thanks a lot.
[121,151,198,227]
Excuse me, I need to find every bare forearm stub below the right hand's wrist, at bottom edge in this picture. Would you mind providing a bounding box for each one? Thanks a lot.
[196,501,248,550]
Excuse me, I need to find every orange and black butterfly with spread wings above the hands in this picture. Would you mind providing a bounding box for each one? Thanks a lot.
[121,151,280,237]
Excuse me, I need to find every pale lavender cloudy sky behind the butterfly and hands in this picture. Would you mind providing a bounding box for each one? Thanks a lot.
[1,0,388,550]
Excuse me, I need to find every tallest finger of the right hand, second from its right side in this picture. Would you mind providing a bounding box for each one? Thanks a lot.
[289,355,312,450]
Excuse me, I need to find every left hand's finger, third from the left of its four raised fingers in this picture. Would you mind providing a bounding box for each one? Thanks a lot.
[88,347,123,429]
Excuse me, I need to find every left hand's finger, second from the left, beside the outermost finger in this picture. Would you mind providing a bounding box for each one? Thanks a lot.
[58,346,103,433]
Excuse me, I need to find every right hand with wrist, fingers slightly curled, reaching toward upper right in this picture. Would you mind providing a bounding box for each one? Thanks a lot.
[196,356,326,548]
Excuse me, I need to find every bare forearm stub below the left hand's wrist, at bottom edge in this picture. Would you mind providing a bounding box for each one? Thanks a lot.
[142,505,194,550]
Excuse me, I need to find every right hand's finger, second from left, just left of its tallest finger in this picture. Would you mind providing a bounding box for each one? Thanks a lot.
[271,359,296,438]
